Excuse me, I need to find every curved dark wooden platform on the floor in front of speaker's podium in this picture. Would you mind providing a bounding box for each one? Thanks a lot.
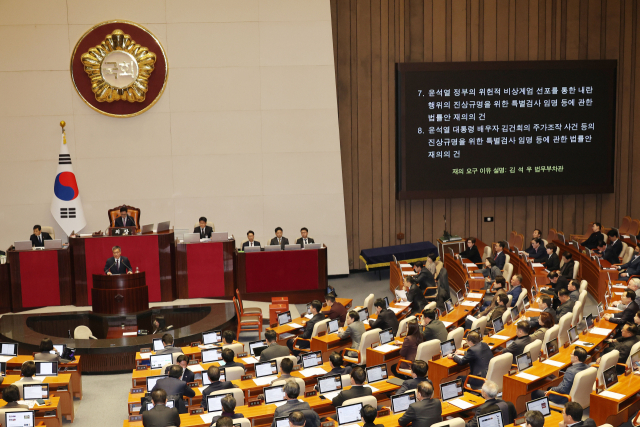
[0,302,236,374]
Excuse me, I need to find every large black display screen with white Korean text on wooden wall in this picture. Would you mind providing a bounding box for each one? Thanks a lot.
[397,61,616,199]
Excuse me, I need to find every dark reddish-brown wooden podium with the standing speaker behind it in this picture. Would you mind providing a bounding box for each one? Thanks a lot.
[91,272,149,315]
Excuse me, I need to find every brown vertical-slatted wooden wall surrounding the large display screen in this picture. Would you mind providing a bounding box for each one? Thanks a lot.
[330,0,640,269]
